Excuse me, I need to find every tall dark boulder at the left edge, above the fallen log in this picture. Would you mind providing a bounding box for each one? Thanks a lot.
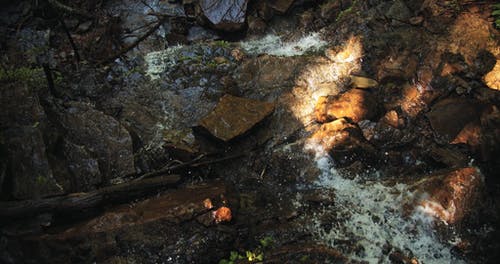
[0,82,62,199]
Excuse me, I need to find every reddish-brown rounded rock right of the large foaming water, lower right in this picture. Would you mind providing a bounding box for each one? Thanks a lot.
[413,167,484,224]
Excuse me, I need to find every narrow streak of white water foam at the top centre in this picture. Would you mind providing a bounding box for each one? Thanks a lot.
[240,32,327,57]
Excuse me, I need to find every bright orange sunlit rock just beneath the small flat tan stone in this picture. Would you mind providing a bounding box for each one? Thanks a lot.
[314,89,378,123]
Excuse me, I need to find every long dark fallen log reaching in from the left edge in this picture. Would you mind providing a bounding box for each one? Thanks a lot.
[0,175,181,222]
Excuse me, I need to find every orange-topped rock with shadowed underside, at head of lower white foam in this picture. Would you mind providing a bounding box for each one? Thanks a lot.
[308,118,376,166]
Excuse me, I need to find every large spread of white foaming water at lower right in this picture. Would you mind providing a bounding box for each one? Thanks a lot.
[306,144,462,263]
